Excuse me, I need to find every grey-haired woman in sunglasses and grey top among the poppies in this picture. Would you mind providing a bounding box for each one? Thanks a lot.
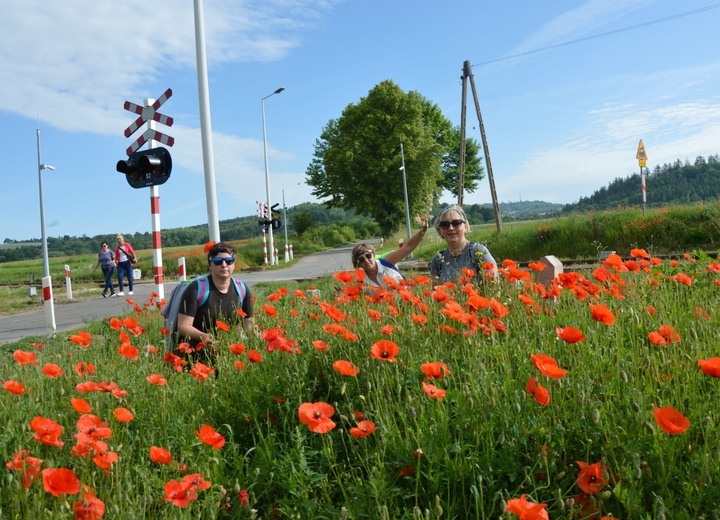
[430,205,498,285]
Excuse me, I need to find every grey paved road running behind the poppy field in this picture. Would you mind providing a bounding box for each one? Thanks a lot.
[0,244,355,344]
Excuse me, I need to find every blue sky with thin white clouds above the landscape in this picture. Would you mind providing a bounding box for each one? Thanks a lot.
[0,0,720,244]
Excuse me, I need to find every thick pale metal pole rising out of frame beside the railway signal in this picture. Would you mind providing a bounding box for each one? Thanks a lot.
[193,0,220,242]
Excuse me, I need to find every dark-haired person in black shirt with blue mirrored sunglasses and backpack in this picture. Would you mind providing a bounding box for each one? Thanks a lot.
[177,242,255,361]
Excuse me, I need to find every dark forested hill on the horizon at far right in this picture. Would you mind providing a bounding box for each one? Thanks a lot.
[562,154,720,213]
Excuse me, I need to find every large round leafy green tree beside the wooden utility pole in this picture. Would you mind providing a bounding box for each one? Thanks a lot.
[306,81,483,234]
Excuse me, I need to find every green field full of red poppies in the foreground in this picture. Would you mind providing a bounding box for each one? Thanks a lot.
[0,249,720,520]
